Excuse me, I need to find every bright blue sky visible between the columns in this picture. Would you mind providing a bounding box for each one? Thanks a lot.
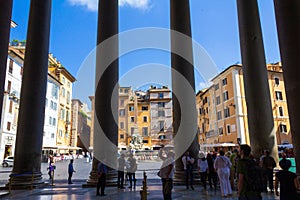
[11,0,279,105]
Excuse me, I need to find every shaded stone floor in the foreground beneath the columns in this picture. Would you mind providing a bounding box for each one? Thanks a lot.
[1,180,279,200]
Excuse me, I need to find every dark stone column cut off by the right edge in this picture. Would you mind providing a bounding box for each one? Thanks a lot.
[274,0,300,174]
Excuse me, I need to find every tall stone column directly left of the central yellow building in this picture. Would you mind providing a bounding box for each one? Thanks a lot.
[87,0,119,186]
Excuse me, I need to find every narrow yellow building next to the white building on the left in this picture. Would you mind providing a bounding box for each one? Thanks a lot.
[48,57,76,153]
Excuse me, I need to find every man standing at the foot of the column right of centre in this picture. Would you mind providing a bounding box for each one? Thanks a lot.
[182,151,195,190]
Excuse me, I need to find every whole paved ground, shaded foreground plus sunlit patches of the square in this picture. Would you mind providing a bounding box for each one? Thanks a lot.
[0,159,279,200]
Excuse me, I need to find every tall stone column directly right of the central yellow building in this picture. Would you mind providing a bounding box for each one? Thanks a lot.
[170,0,199,184]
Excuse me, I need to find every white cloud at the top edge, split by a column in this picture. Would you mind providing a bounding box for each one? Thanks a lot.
[68,0,151,11]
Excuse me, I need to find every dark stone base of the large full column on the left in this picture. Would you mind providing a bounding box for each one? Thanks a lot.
[6,172,44,190]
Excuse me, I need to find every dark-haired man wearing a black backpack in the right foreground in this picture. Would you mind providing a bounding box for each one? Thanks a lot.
[237,144,263,200]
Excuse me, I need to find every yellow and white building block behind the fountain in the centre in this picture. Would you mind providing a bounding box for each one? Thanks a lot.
[118,86,173,149]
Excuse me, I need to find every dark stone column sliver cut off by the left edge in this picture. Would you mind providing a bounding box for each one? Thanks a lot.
[0,0,12,127]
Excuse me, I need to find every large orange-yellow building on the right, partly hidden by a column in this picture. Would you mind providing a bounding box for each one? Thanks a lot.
[196,63,291,150]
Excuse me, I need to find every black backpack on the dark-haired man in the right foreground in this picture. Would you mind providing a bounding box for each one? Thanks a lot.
[241,159,265,193]
